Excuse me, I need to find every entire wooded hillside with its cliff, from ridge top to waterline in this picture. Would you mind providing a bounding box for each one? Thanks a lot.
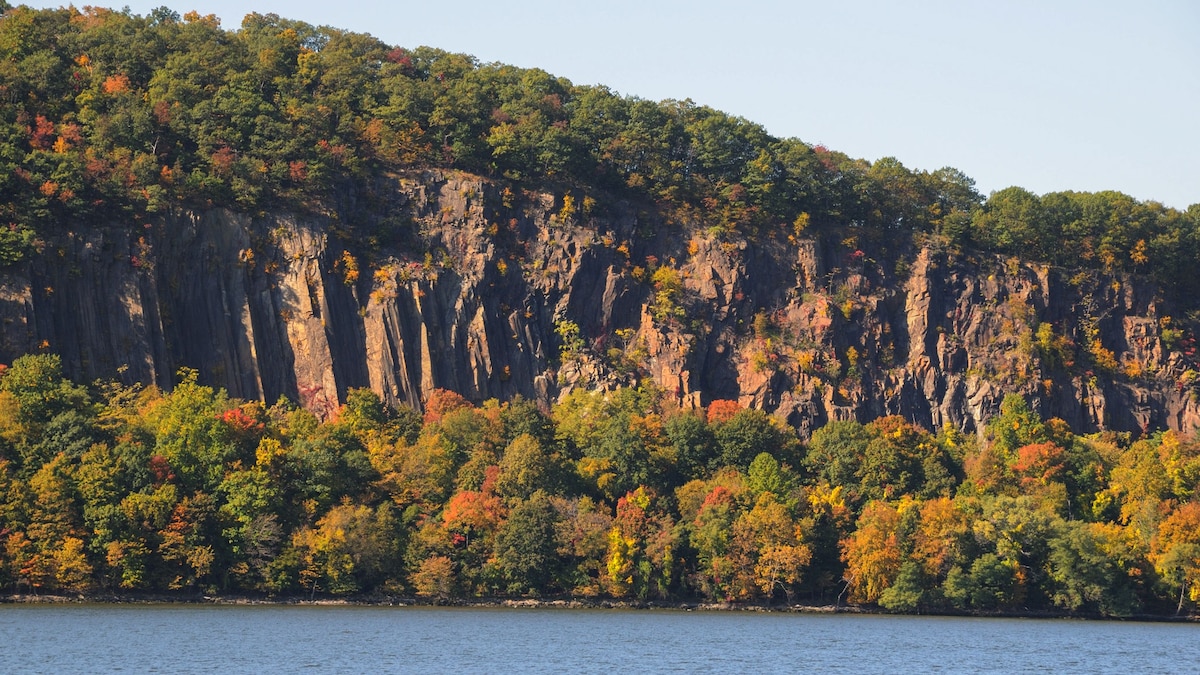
[0,5,1200,616]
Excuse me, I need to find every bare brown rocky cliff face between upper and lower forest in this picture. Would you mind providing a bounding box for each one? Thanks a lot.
[0,172,1200,435]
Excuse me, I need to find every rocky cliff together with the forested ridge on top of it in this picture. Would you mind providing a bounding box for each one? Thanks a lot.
[0,8,1198,435]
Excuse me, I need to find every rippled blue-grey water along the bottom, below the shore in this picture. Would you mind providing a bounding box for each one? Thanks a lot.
[0,605,1200,674]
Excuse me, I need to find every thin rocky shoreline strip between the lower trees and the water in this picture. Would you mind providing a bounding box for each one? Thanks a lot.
[0,593,1200,623]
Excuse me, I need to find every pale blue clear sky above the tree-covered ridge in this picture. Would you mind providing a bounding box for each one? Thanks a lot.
[23,0,1200,209]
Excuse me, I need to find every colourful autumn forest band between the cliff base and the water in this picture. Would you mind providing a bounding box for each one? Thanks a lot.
[0,354,1200,616]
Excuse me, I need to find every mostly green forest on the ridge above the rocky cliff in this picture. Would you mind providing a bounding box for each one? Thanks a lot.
[0,4,1200,296]
